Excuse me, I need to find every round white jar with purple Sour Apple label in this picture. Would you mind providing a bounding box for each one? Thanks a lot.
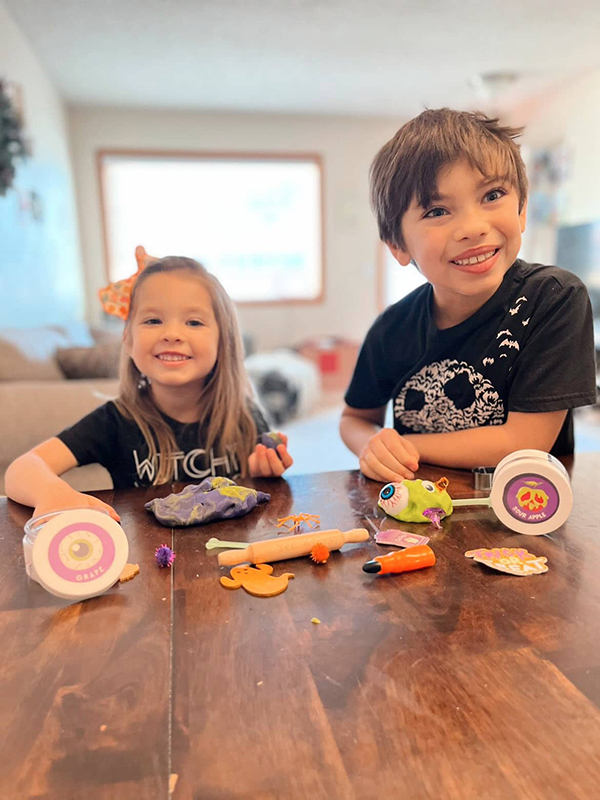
[490,450,573,536]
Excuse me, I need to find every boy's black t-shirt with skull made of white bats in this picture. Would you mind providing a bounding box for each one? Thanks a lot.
[345,259,596,455]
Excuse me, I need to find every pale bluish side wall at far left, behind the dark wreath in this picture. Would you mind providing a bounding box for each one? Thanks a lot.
[0,3,85,327]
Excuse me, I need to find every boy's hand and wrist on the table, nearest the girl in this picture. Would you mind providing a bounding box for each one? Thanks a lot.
[340,406,420,483]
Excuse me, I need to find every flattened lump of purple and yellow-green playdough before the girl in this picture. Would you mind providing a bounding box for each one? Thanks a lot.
[145,478,271,525]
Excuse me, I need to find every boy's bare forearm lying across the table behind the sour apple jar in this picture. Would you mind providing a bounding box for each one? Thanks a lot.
[402,410,567,468]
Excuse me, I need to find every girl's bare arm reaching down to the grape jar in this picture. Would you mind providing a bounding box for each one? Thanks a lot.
[5,437,119,521]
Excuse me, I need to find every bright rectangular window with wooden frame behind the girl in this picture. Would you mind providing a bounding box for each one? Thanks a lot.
[98,151,323,303]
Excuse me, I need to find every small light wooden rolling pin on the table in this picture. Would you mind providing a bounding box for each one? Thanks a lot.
[219,528,369,567]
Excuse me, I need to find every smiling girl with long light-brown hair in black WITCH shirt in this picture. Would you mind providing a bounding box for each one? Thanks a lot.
[6,256,292,520]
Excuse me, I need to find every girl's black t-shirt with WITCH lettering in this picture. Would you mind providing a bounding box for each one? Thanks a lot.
[58,401,269,489]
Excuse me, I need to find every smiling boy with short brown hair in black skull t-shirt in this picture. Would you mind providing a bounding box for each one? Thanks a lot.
[340,109,596,482]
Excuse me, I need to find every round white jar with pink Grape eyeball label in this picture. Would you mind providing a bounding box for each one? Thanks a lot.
[23,508,129,600]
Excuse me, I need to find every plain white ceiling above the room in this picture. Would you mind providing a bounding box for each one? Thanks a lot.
[7,0,600,116]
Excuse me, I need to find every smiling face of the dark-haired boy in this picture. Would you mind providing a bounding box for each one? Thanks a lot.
[390,159,526,327]
